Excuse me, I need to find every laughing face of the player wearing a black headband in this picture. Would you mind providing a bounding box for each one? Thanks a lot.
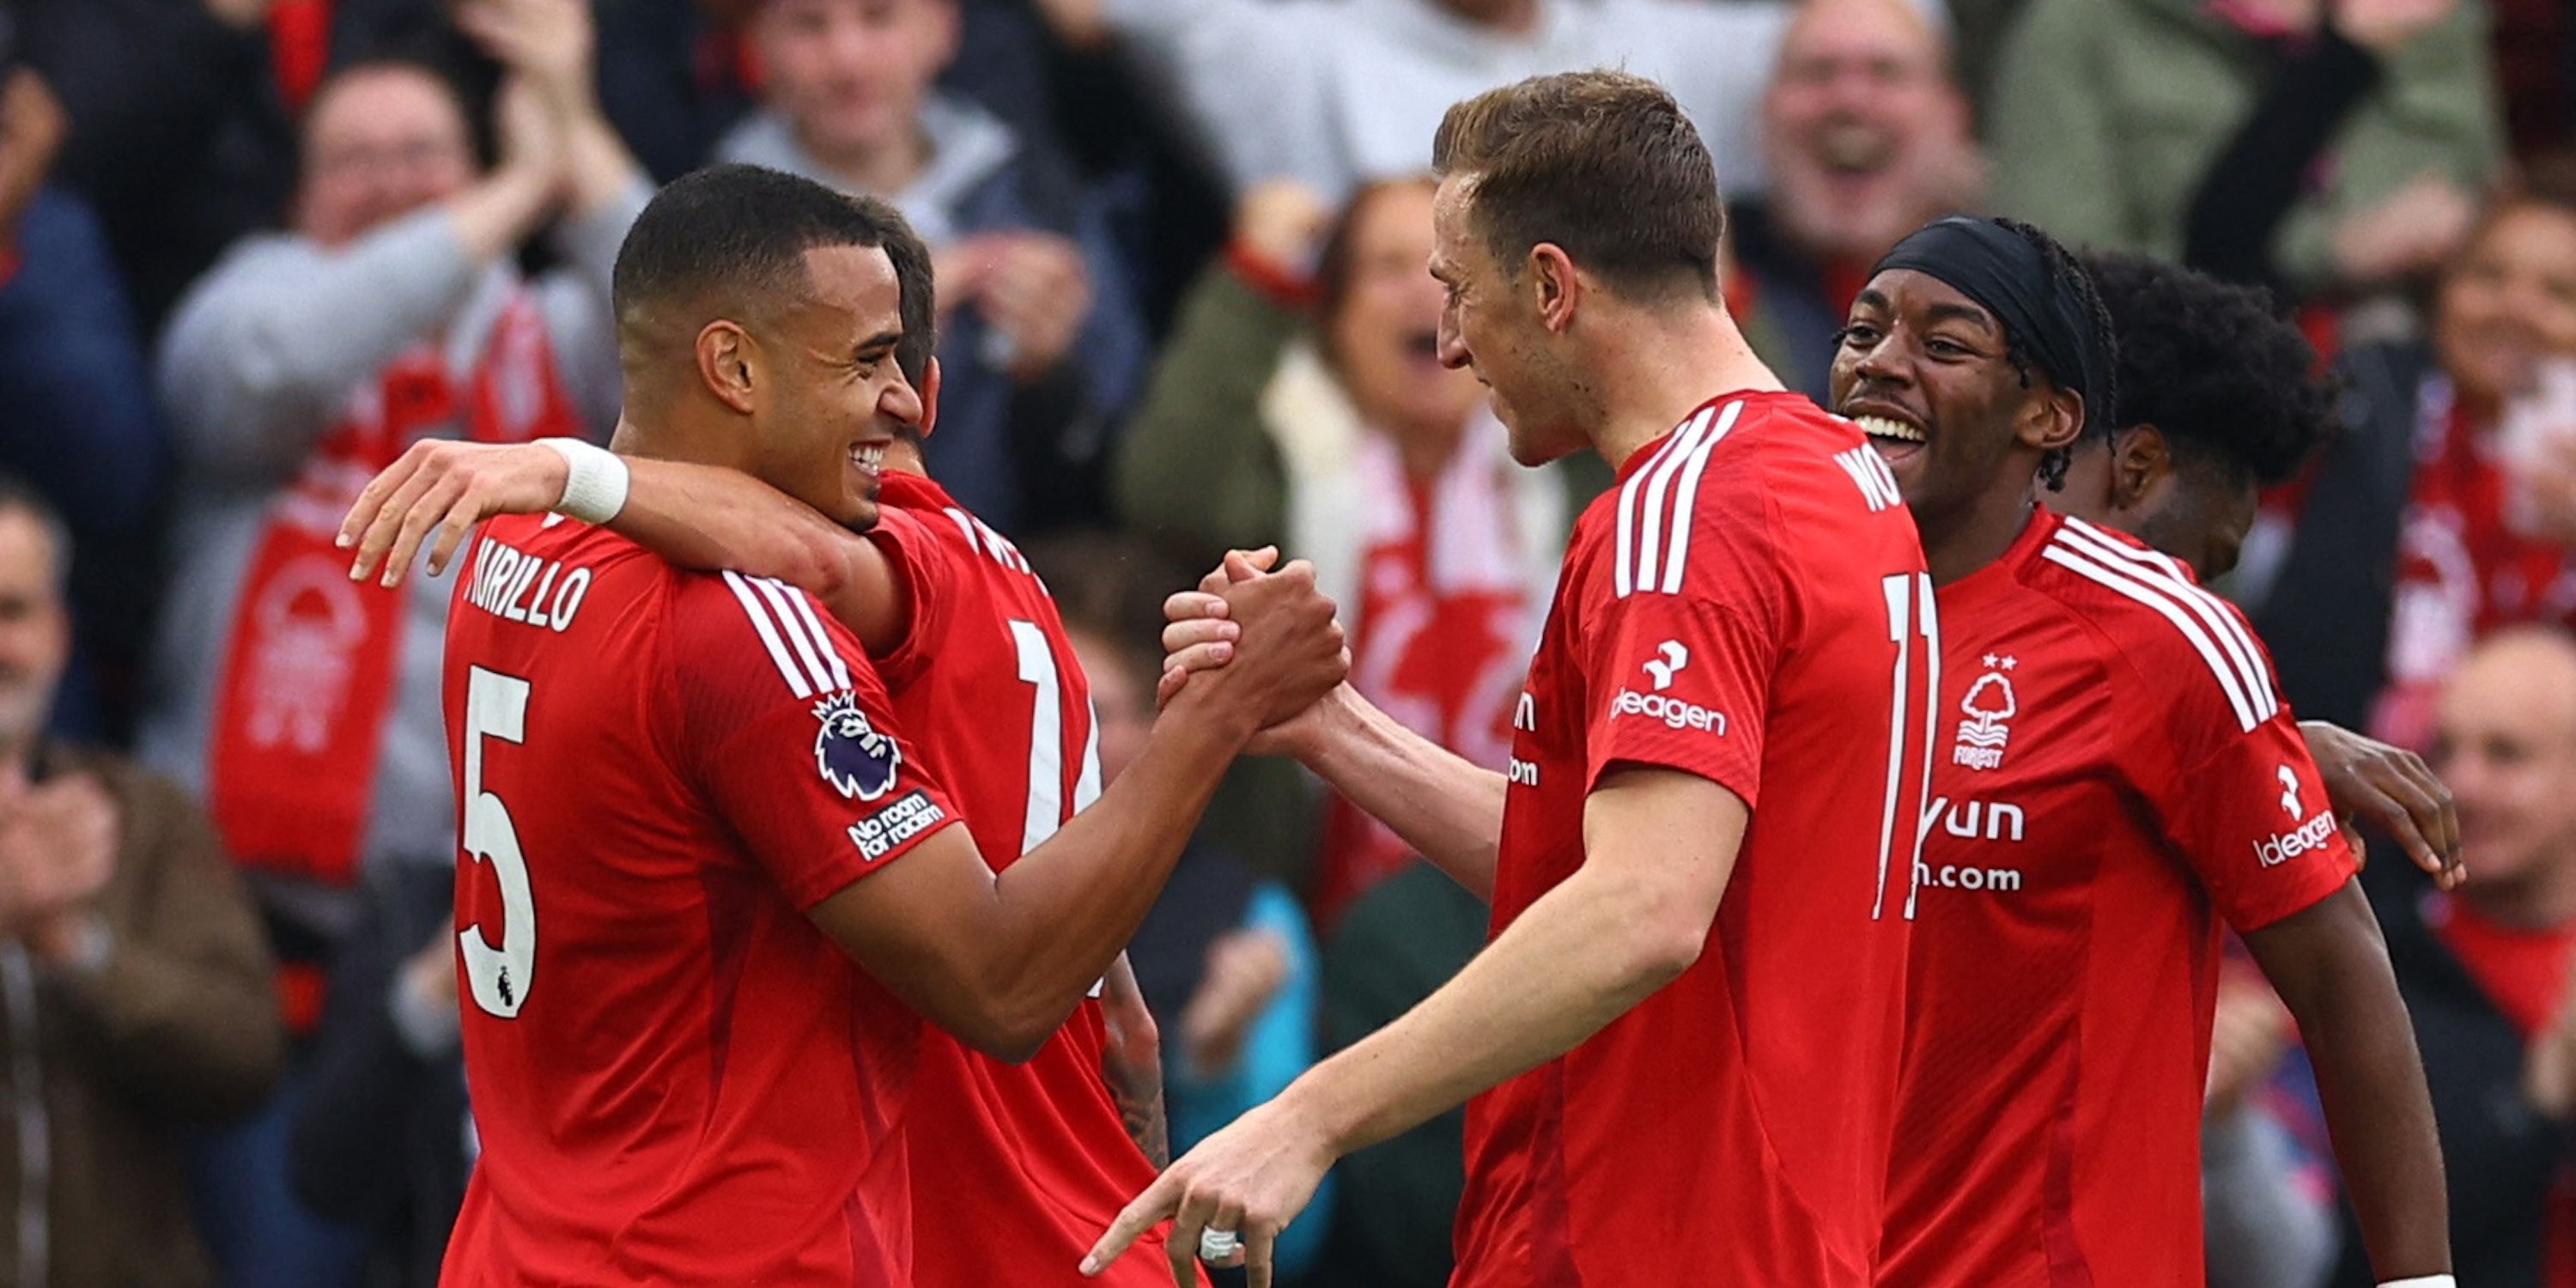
[1832,268,2081,546]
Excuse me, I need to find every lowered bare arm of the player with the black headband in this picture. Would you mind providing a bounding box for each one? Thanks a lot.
[2246,886,2450,1280]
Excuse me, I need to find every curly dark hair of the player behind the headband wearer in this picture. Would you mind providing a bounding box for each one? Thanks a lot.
[2084,252,2336,487]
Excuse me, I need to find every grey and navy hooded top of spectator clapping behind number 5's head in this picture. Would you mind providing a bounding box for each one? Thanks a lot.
[716,93,1151,536]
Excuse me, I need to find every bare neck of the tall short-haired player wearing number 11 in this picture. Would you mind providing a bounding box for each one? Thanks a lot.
[1587,304,1788,469]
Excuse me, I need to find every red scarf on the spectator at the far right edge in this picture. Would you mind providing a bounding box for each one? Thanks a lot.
[2370,376,2576,747]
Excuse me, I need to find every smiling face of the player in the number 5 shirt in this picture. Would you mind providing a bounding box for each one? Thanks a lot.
[752,245,922,531]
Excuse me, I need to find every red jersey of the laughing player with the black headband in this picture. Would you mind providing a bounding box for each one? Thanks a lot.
[1878,510,2354,1288]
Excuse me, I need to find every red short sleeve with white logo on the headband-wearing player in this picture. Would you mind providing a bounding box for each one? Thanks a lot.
[2161,708,2360,930]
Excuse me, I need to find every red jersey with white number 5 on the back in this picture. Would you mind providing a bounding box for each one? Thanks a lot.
[440,518,956,1288]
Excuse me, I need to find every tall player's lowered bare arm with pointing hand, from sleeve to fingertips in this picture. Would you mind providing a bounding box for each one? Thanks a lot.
[1082,768,1752,1288]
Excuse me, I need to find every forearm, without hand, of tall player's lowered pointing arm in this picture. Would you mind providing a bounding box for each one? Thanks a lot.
[1280,866,1705,1154]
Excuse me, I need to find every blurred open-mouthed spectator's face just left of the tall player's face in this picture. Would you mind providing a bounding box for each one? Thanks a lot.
[1324,183,1479,453]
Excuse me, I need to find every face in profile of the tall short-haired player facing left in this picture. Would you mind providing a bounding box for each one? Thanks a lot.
[1430,175,1589,466]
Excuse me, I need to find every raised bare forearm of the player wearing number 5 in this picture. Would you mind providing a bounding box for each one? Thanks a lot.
[981,701,1252,1041]
